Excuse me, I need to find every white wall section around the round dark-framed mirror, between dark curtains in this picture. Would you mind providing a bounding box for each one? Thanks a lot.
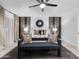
[31,17,49,37]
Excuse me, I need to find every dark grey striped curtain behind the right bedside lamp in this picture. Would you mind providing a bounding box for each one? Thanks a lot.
[49,17,61,38]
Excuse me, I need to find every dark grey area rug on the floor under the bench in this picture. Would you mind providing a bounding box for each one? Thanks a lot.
[1,47,79,59]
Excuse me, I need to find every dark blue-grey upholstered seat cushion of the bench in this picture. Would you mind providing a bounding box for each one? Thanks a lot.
[19,42,60,50]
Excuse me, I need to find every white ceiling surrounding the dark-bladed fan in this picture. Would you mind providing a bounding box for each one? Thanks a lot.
[0,0,79,16]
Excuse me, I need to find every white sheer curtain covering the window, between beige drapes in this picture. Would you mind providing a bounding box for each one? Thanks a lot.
[4,10,14,47]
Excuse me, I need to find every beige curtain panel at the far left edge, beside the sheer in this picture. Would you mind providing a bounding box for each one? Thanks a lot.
[0,9,4,50]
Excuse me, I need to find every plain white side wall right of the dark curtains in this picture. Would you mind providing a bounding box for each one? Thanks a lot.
[62,10,77,47]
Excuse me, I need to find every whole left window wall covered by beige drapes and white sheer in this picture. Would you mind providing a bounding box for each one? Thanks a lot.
[0,5,19,49]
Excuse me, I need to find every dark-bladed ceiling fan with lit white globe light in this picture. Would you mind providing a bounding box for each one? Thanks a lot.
[29,0,58,12]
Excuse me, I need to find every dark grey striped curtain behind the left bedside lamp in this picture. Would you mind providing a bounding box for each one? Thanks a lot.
[19,17,31,38]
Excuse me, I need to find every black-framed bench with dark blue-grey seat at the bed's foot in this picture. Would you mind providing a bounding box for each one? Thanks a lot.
[18,40,61,56]
